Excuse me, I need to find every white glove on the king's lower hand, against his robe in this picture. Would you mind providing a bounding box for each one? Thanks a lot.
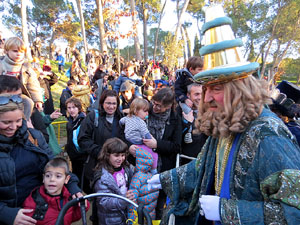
[199,195,220,221]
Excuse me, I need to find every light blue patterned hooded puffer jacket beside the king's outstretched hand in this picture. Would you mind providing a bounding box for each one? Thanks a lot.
[128,148,159,221]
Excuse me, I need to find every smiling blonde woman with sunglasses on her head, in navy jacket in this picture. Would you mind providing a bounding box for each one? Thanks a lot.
[0,94,82,225]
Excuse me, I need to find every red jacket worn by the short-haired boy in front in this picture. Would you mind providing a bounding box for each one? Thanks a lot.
[23,185,90,225]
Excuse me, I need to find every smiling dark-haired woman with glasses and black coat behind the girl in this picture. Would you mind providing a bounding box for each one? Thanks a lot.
[78,90,125,193]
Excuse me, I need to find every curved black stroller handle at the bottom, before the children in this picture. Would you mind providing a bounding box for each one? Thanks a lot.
[55,193,152,225]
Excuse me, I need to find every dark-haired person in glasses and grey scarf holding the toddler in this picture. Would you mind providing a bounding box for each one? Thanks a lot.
[129,88,181,219]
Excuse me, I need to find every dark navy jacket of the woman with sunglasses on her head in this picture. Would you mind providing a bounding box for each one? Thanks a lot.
[0,120,53,224]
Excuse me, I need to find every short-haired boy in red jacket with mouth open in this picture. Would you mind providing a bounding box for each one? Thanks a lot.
[23,157,89,225]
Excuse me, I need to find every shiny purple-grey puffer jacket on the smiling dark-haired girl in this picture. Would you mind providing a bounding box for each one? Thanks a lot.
[94,167,133,225]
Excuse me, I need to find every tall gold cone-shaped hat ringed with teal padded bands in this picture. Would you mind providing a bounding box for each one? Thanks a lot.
[194,3,259,84]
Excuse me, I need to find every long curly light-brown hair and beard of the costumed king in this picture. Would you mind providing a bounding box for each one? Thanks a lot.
[196,76,271,138]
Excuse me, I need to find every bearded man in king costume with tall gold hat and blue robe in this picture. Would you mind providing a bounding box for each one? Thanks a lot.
[148,4,300,225]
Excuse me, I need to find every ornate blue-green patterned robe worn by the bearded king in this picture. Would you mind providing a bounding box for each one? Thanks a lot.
[160,109,300,225]
